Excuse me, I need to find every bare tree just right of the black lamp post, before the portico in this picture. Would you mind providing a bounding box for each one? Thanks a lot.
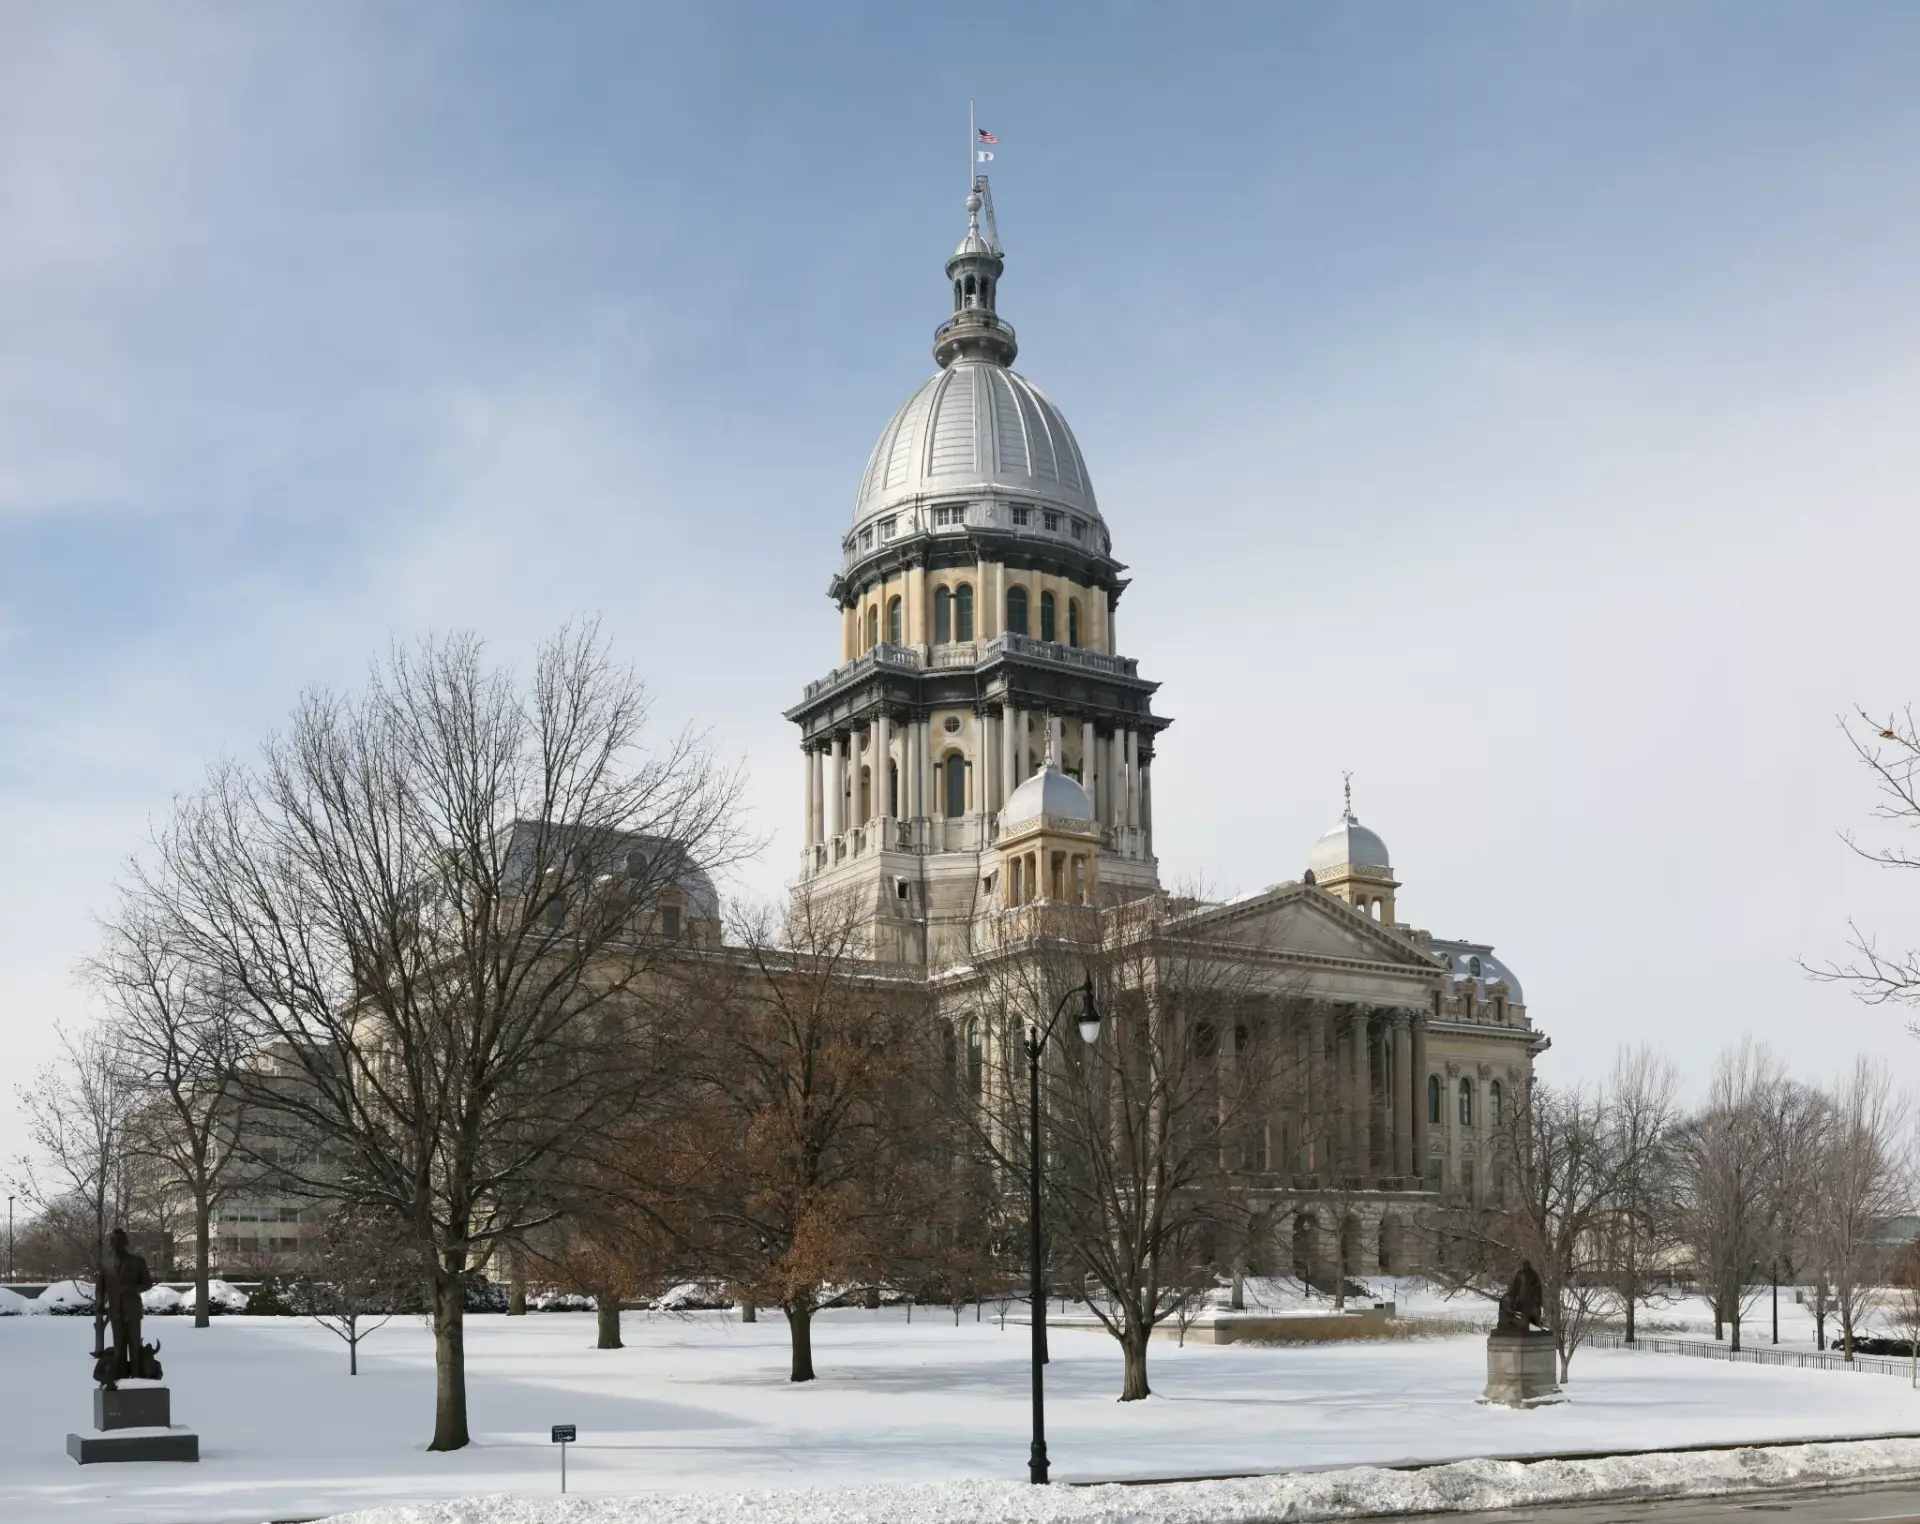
[966,896,1298,1401]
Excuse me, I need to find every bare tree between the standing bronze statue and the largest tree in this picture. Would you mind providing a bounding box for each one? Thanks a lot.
[84,898,242,1328]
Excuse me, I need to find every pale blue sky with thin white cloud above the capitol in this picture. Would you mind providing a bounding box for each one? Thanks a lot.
[0,0,1920,1154]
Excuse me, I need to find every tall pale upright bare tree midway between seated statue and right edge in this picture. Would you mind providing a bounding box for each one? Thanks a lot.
[1676,1038,1784,1349]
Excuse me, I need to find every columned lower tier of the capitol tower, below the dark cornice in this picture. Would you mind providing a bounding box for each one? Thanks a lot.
[801,702,1152,856]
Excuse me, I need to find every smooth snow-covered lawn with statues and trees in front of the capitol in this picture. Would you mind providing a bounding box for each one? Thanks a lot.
[0,1309,1920,1524]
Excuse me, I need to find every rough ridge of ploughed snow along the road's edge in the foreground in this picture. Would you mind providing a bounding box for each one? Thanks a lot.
[323,1440,1920,1524]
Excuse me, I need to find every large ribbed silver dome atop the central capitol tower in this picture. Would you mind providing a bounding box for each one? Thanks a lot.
[854,359,1100,524]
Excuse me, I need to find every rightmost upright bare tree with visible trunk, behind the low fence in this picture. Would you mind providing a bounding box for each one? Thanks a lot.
[1812,1058,1912,1361]
